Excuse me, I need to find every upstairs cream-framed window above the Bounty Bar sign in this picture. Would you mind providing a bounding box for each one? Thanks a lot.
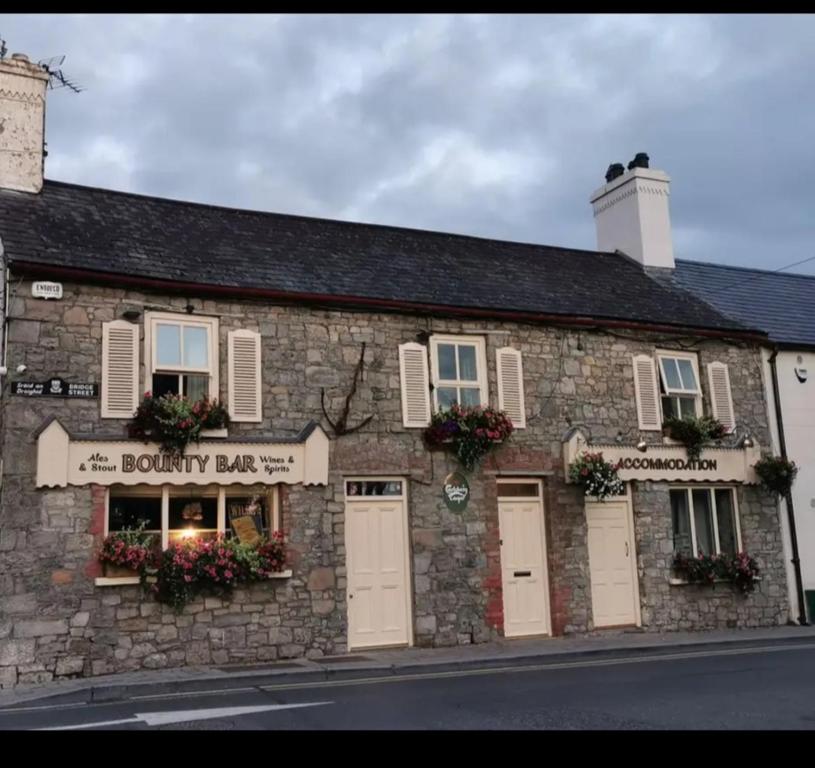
[144,312,218,400]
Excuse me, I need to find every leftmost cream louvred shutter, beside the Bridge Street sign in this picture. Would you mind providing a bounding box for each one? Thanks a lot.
[102,320,139,419]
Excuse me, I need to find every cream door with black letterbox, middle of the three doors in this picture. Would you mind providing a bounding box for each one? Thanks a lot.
[498,480,551,637]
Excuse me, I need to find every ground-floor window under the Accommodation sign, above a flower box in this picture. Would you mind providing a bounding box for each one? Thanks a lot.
[670,488,741,555]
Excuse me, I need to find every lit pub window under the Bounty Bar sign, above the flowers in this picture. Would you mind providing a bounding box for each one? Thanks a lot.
[107,485,280,548]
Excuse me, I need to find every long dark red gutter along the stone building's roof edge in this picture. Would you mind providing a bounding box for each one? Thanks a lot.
[7,261,768,345]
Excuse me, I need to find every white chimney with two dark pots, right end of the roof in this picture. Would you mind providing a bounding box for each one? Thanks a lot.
[591,153,674,269]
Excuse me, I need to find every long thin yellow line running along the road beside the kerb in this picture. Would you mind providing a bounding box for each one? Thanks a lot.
[6,643,815,717]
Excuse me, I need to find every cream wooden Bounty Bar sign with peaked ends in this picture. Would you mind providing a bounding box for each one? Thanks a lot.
[37,420,328,487]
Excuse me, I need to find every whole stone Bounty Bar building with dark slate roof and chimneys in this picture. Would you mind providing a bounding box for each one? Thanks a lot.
[0,58,787,685]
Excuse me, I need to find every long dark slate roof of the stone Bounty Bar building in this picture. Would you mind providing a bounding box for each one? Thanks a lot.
[0,181,750,332]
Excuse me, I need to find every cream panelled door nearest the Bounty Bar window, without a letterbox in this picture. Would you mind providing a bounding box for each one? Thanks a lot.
[345,478,411,648]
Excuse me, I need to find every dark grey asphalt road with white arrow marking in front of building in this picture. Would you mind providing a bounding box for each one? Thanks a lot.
[0,644,815,731]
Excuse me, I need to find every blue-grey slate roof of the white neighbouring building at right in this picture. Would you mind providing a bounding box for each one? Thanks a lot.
[672,259,815,347]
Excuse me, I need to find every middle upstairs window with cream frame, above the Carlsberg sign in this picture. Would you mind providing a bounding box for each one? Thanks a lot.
[430,335,488,410]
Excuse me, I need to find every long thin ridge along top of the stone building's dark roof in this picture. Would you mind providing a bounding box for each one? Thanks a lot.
[38,179,620,258]
